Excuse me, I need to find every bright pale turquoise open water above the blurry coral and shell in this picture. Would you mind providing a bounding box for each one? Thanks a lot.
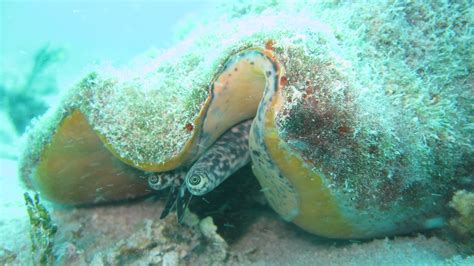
[0,0,211,87]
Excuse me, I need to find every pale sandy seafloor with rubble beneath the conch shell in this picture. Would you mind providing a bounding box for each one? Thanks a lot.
[0,149,474,265]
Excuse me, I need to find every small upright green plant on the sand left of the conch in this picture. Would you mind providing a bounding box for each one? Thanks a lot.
[24,192,58,265]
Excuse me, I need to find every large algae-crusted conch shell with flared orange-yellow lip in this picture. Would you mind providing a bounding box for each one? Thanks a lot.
[20,2,472,238]
